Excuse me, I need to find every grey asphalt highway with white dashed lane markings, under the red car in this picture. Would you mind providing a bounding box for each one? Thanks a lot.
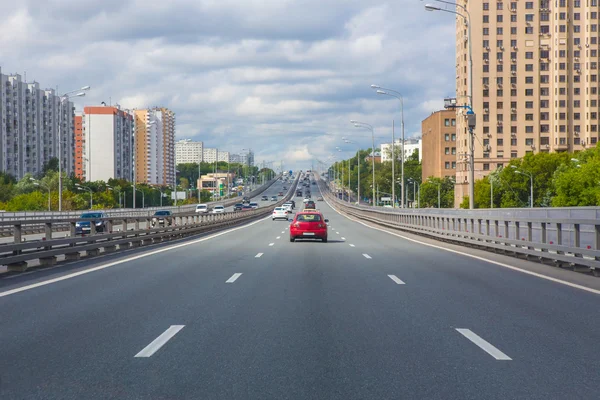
[0,178,600,399]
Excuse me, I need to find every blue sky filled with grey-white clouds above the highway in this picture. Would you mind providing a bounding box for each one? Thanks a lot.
[0,0,455,168]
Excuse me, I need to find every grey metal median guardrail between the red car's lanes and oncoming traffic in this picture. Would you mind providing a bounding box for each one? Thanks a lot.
[0,175,295,272]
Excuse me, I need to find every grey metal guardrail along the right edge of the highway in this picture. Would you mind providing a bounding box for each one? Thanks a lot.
[319,180,600,276]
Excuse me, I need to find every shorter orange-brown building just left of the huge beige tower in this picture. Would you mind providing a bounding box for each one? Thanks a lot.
[421,110,456,182]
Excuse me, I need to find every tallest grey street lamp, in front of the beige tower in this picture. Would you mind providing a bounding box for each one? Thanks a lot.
[425,0,475,209]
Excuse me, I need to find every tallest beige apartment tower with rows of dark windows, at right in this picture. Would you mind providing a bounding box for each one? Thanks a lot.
[455,0,600,205]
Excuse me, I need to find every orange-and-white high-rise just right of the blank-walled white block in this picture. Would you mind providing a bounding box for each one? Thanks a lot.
[134,108,175,185]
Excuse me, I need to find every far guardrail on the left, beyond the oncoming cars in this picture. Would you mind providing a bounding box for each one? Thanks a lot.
[0,176,280,237]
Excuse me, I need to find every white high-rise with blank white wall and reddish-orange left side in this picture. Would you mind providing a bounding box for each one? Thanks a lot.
[81,106,133,182]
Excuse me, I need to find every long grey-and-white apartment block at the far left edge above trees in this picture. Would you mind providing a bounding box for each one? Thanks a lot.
[0,70,75,179]
